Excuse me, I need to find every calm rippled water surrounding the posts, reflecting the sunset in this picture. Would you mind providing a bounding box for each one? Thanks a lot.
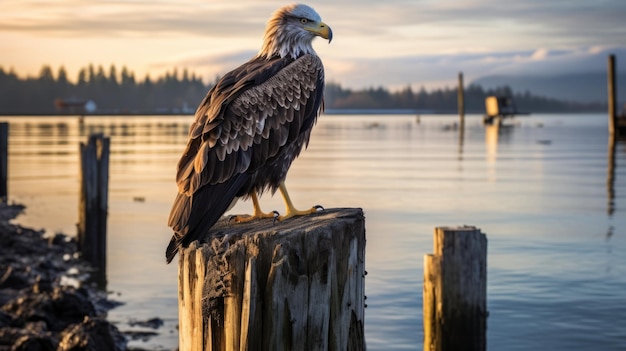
[0,114,626,350]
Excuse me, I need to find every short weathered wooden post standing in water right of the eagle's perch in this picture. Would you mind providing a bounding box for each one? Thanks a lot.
[423,226,487,351]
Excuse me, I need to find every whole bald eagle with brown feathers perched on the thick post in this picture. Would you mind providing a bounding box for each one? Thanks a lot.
[165,4,332,263]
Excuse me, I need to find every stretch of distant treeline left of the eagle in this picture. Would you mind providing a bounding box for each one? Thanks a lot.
[0,65,209,114]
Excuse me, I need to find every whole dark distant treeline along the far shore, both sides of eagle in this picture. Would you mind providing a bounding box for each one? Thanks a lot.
[0,65,606,115]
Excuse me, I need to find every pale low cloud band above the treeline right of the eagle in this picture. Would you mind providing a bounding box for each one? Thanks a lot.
[314,47,626,89]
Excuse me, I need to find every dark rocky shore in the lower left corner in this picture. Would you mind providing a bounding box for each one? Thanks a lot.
[0,203,134,351]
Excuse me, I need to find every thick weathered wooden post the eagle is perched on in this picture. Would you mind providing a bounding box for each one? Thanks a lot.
[178,209,365,351]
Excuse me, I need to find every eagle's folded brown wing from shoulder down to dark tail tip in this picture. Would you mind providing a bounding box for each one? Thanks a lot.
[166,55,324,262]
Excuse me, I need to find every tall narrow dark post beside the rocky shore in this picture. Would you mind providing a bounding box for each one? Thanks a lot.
[78,133,110,283]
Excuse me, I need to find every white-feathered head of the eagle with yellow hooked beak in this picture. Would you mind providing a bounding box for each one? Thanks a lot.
[259,4,333,58]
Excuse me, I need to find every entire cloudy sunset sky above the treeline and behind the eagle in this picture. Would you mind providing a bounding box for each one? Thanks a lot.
[0,0,626,90]
